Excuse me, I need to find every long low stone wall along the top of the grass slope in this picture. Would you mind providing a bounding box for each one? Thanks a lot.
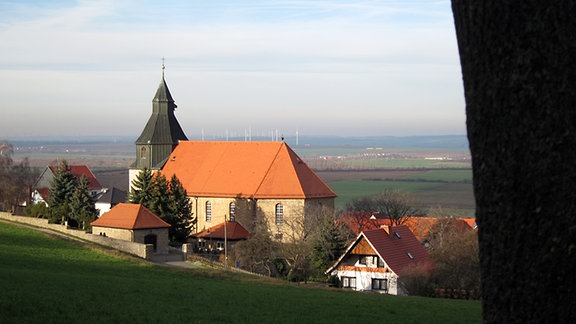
[0,212,154,260]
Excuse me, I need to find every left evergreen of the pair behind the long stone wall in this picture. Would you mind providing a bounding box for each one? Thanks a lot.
[48,160,77,224]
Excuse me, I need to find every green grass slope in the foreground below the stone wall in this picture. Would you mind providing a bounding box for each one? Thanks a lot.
[0,222,481,323]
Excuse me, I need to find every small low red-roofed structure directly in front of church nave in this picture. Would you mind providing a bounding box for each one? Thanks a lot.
[192,221,250,252]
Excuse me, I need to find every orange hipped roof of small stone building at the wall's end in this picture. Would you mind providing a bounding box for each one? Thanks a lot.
[91,203,170,229]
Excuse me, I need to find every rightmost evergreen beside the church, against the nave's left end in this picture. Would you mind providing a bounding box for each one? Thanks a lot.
[169,175,195,243]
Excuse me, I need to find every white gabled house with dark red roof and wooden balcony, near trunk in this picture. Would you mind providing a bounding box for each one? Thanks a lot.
[325,225,433,295]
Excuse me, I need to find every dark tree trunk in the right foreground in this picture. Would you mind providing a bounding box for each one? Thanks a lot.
[452,0,576,323]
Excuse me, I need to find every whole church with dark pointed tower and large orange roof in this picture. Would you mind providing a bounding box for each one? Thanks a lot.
[129,65,336,242]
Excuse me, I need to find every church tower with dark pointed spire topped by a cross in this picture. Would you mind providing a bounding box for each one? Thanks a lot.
[129,64,188,186]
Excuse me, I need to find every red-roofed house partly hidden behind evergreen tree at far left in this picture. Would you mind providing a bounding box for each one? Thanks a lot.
[32,165,105,205]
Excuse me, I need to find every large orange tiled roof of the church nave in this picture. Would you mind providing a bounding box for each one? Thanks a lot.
[162,141,336,198]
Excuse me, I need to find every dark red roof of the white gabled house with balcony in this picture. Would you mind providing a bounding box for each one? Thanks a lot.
[326,225,433,275]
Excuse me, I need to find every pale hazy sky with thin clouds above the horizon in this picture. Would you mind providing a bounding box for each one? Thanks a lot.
[0,0,465,139]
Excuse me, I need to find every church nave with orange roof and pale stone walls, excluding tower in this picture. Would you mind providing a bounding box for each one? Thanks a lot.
[161,141,336,241]
